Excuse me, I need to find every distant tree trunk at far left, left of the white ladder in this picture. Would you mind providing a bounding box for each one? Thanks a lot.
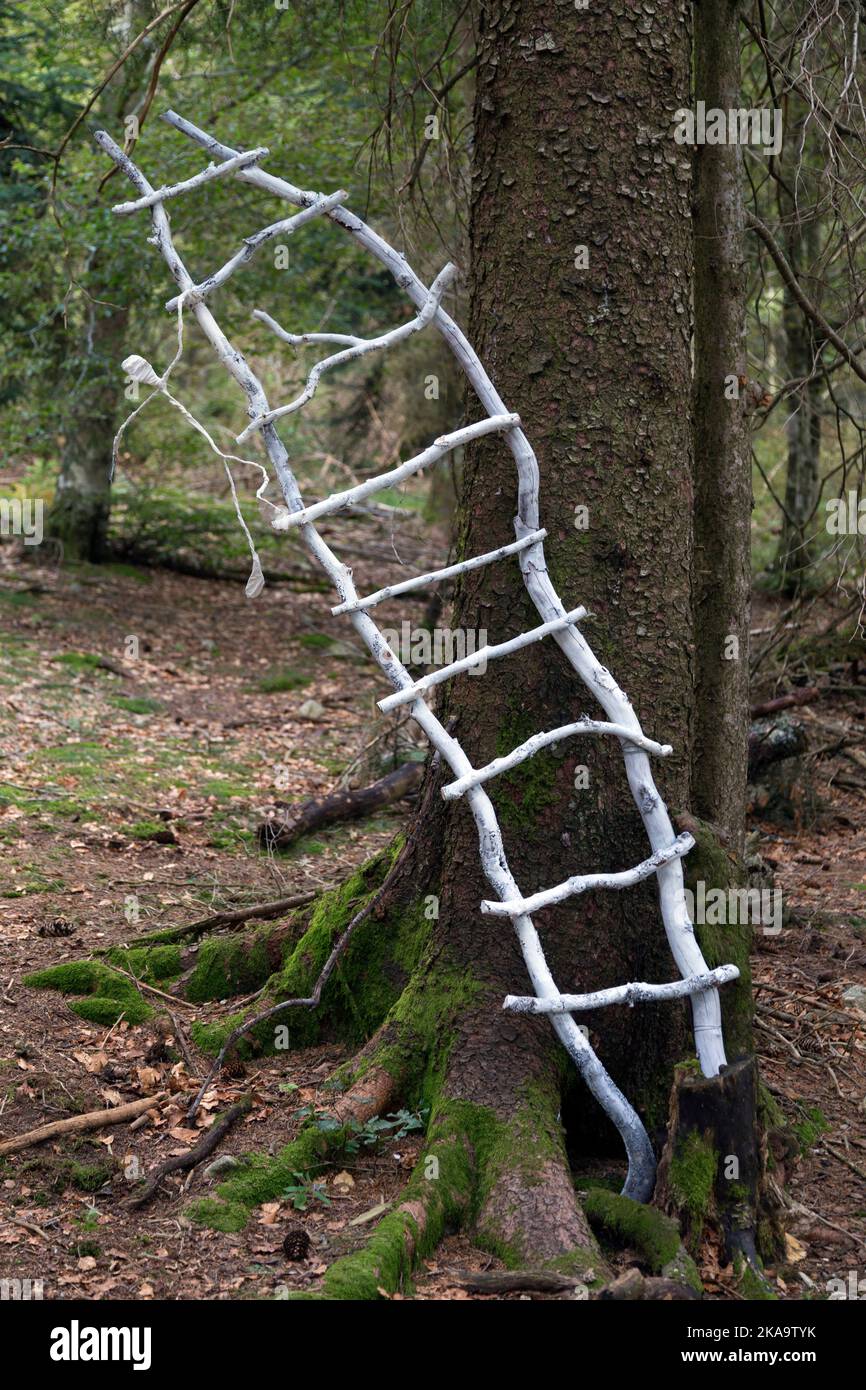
[46,304,132,562]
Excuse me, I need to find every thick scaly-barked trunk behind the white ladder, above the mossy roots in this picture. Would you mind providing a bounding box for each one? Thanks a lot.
[441,0,692,1184]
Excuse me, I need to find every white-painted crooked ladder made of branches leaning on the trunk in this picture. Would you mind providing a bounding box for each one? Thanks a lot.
[96,111,738,1201]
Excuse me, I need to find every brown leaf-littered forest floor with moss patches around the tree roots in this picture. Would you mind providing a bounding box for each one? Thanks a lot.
[0,542,866,1300]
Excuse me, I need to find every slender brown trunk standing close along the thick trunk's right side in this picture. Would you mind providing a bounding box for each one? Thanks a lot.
[692,0,752,852]
